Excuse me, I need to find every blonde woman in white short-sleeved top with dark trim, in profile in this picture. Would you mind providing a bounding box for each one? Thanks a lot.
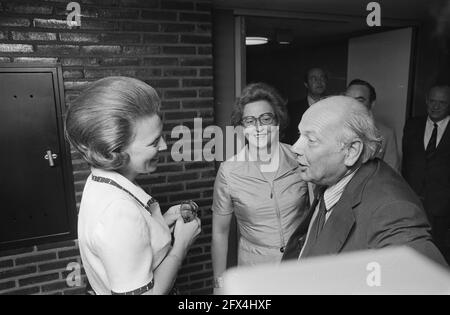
[66,77,200,295]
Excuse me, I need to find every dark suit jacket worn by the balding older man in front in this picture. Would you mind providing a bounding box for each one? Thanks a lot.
[283,159,446,265]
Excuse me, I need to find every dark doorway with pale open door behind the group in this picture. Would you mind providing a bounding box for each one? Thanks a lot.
[245,16,415,152]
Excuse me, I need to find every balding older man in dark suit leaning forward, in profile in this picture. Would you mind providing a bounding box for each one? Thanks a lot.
[283,96,445,264]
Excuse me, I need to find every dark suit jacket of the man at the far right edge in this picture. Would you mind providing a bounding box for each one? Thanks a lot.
[402,117,450,216]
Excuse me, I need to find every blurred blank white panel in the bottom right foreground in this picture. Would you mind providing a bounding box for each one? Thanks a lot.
[223,246,450,295]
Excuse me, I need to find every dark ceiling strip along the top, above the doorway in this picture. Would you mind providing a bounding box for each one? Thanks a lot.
[213,0,449,45]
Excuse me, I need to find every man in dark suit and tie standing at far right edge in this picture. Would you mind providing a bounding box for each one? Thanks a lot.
[402,85,450,259]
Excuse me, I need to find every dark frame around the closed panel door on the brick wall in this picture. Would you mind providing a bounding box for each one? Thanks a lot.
[0,63,78,250]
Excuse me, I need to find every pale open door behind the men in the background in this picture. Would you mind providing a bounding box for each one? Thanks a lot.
[347,28,413,154]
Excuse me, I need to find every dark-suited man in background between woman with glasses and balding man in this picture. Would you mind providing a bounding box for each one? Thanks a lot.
[283,68,328,144]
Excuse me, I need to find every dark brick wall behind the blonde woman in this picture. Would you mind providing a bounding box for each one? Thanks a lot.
[0,0,215,294]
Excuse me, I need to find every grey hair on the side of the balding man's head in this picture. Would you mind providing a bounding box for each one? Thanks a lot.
[340,104,383,164]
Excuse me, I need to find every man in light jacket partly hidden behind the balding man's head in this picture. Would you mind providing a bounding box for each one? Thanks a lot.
[345,79,400,172]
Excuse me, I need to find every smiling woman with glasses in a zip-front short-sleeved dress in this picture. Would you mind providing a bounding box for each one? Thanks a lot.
[212,83,308,292]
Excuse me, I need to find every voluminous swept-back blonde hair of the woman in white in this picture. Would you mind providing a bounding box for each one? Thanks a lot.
[64,77,161,170]
